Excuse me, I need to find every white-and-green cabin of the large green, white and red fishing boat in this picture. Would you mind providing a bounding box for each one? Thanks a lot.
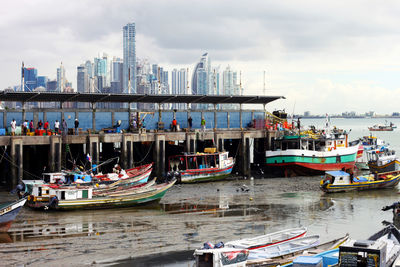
[272,134,349,151]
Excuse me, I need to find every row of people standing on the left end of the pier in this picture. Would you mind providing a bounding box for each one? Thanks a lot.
[10,119,79,135]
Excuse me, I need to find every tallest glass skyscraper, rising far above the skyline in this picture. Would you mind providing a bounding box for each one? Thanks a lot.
[123,23,136,94]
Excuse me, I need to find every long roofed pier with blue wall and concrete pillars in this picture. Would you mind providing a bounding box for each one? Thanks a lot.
[0,92,282,191]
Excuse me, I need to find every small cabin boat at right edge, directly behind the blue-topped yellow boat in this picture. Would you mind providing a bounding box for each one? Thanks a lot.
[367,148,400,173]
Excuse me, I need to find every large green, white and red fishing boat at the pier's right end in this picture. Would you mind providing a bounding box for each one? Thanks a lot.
[265,129,359,176]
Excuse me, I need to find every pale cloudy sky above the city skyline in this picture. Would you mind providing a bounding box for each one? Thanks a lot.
[0,0,400,114]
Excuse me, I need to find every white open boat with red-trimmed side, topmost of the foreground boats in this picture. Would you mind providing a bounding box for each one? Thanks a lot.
[225,227,307,250]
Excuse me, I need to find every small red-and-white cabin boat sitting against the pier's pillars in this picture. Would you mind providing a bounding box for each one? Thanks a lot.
[168,148,235,183]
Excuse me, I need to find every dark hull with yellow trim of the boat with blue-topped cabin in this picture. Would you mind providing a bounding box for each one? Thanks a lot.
[320,174,400,193]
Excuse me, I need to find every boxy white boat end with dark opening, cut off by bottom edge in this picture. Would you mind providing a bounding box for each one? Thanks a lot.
[194,248,249,267]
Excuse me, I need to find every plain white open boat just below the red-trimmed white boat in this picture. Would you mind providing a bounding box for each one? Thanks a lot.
[249,235,319,260]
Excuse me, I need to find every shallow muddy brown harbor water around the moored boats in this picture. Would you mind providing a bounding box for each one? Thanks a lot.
[0,118,400,266]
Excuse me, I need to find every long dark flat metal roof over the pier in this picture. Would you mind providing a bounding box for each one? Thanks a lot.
[0,91,284,104]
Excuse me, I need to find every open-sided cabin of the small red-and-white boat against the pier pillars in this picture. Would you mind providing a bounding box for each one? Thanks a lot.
[168,152,233,171]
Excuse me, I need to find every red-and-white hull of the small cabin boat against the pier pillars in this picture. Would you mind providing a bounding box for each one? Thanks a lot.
[180,163,234,183]
